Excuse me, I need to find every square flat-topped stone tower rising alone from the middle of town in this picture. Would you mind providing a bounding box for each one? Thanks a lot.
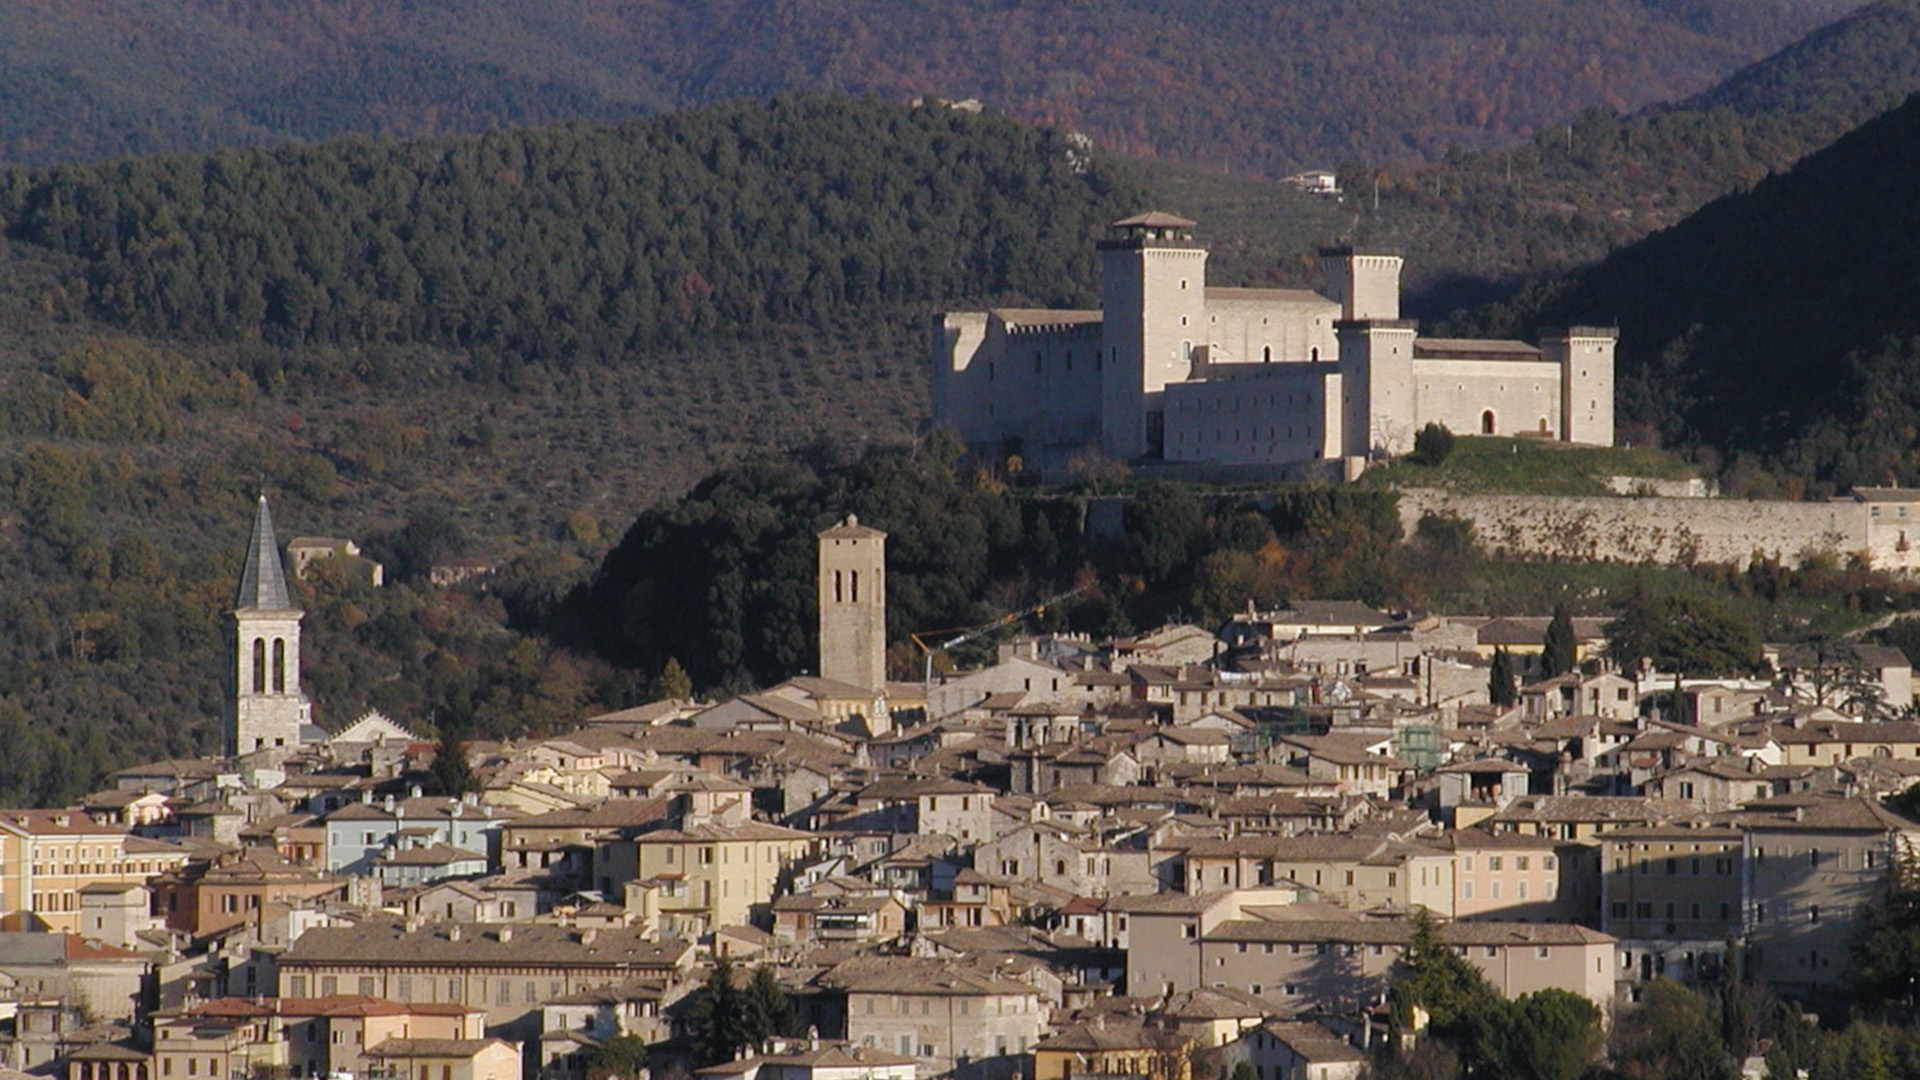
[820,513,887,696]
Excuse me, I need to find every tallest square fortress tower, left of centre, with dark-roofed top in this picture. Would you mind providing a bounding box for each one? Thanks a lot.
[1098,211,1208,461]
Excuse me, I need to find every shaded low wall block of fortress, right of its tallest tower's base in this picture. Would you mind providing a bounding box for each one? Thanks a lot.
[1164,363,1340,465]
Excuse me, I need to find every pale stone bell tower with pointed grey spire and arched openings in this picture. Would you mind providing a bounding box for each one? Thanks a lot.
[225,496,313,755]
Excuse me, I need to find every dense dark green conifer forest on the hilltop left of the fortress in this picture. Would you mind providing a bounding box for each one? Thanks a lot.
[0,98,1137,359]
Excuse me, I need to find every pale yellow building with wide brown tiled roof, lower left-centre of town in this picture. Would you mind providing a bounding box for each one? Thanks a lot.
[634,821,816,936]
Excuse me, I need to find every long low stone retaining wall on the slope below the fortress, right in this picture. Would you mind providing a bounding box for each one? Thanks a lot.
[1400,488,1920,571]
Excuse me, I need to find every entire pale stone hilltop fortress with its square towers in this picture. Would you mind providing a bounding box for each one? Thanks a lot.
[931,213,1617,465]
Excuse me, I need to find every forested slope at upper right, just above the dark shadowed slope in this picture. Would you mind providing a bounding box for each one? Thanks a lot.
[1348,0,1920,319]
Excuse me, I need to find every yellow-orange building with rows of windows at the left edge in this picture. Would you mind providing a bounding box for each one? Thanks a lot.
[0,809,186,934]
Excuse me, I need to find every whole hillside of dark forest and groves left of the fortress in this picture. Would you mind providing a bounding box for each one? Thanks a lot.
[0,100,1140,805]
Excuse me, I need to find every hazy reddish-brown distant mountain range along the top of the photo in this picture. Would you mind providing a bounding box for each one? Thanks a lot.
[0,0,1859,173]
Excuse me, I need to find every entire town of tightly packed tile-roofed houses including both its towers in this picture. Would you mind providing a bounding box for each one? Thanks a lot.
[0,503,1920,1080]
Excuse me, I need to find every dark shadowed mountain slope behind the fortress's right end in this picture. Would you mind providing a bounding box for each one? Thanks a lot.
[1443,98,1920,482]
